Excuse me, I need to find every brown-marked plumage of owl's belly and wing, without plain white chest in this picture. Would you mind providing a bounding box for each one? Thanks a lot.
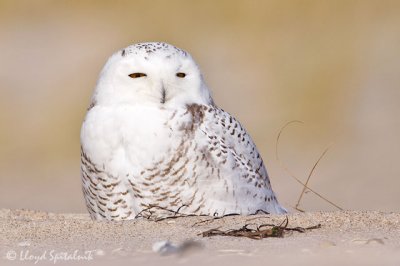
[81,104,286,220]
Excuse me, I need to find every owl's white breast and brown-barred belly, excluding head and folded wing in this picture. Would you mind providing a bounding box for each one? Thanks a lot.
[81,103,203,219]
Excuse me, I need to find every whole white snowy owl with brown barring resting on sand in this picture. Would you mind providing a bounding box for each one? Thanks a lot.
[81,43,286,220]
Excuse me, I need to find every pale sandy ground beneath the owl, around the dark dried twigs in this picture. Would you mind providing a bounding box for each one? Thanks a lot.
[0,209,400,265]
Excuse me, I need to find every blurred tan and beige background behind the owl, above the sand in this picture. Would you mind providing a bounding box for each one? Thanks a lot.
[0,0,400,212]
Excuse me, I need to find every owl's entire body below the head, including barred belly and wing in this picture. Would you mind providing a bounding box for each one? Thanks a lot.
[81,104,285,220]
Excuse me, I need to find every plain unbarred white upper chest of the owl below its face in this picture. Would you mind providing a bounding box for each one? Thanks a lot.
[81,107,191,176]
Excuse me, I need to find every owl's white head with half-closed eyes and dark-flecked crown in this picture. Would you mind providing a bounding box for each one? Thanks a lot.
[92,43,212,108]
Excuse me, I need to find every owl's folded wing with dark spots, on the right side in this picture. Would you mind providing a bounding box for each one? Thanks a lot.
[192,106,286,214]
